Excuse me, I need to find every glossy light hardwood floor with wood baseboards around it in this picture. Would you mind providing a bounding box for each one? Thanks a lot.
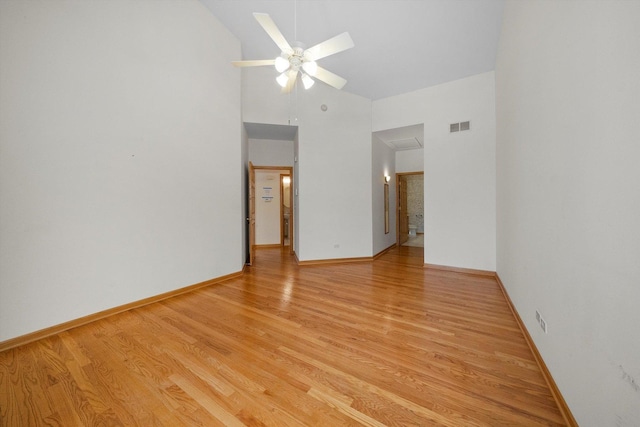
[0,247,564,427]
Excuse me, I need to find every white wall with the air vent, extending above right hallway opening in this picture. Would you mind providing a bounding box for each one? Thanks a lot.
[373,72,496,271]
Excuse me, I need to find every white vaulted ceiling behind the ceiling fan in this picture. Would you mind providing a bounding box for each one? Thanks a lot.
[200,0,504,100]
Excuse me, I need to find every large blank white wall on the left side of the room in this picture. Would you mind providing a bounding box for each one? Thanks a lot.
[0,0,243,341]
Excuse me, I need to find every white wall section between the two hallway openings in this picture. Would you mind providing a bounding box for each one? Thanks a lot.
[298,84,373,260]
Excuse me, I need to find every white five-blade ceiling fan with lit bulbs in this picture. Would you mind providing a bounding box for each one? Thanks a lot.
[232,13,354,93]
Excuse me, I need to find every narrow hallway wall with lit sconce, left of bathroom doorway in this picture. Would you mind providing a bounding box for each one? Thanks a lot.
[371,135,396,255]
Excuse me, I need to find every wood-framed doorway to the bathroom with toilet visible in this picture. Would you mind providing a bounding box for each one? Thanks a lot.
[396,172,424,247]
